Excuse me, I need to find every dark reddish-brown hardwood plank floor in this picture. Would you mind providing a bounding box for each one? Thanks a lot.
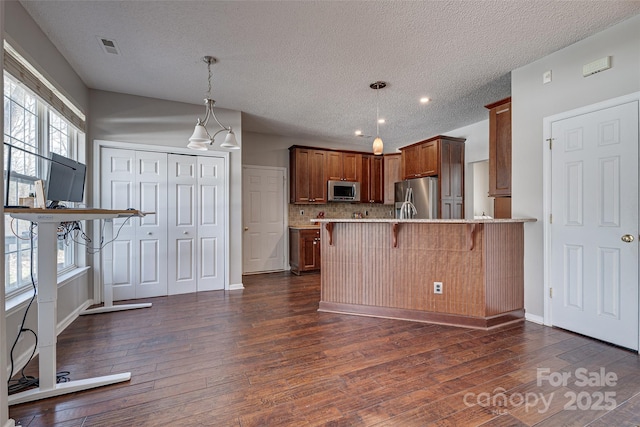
[10,273,640,427]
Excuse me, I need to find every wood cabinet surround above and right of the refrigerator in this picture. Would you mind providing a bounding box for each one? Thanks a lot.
[400,135,465,219]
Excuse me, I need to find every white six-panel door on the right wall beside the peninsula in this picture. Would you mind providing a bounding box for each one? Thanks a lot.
[550,101,638,350]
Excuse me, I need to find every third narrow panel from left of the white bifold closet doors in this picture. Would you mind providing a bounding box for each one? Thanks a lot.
[167,154,198,295]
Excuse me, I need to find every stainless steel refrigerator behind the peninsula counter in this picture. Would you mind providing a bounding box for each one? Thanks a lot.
[395,177,438,219]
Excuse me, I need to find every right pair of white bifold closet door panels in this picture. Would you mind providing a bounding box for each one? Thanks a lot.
[168,154,225,294]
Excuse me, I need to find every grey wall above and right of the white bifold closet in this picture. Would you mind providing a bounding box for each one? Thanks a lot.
[87,90,243,287]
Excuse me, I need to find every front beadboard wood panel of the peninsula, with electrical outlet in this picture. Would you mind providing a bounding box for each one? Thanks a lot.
[321,222,485,317]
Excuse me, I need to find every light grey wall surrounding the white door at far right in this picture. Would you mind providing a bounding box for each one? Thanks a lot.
[511,15,640,318]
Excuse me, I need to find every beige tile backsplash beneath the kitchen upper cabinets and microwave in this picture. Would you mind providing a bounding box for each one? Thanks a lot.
[289,203,394,226]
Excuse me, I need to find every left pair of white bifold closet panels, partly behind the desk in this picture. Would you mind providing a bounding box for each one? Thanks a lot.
[100,148,167,301]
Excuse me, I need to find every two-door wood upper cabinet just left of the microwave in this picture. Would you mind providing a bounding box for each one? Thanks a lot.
[289,147,327,204]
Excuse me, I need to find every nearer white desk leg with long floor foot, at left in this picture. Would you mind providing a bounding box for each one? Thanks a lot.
[8,222,131,405]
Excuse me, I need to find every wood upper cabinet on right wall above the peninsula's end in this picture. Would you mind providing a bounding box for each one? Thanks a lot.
[485,97,511,197]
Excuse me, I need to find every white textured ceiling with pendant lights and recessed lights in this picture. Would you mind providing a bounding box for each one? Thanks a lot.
[21,0,640,152]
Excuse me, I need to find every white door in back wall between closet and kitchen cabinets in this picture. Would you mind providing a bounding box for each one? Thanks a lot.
[242,166,287,274]
